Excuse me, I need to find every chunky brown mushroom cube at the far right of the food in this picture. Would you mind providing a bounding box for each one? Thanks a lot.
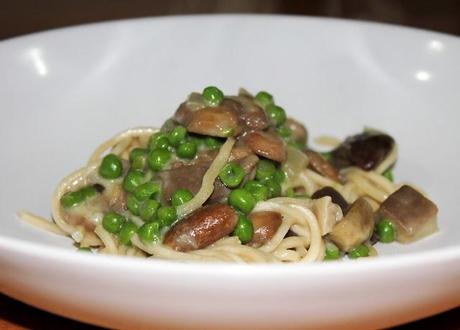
[378,185,438,243]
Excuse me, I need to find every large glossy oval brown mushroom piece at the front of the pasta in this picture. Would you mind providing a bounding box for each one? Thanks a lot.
[163,204,238,252]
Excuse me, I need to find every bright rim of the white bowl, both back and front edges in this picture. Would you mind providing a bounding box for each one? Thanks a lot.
[0,13,460,276]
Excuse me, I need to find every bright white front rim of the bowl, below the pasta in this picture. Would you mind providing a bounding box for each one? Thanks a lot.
[0,236,460,276]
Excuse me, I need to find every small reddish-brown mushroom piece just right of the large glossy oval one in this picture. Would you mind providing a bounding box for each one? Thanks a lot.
[248,211,282,247]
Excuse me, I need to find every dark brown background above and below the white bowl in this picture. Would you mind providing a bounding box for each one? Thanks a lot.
[0,0,460,330]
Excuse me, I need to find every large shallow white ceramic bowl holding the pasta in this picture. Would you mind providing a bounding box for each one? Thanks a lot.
[0,16,460,329]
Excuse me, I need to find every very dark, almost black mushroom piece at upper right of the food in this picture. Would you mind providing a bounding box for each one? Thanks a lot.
[331,132,395,171]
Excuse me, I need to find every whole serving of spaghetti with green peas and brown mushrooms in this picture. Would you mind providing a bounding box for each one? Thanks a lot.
[18,86,437,263]
